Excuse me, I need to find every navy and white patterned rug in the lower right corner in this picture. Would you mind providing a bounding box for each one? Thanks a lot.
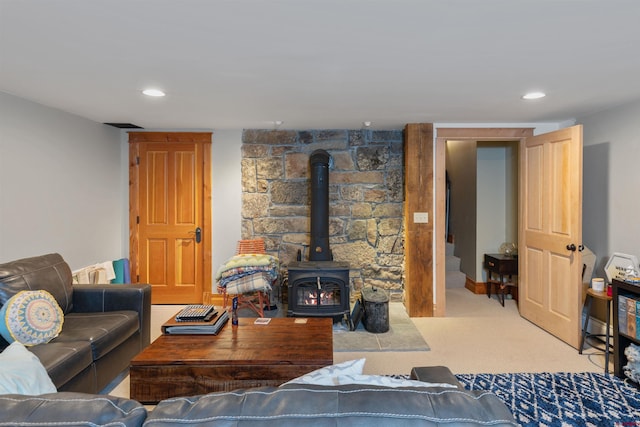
[456,372,640,427]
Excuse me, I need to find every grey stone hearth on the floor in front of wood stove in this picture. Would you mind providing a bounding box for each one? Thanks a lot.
[333,302,429,352]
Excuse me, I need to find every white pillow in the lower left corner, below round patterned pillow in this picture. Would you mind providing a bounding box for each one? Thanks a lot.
[0,341,58,395]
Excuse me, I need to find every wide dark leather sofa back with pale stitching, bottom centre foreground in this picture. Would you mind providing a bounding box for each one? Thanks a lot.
[145,384,518,427]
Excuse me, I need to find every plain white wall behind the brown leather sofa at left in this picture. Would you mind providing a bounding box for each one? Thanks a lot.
[0,93,126,269]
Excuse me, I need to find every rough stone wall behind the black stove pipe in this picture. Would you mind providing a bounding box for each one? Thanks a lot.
[242,130,404,297]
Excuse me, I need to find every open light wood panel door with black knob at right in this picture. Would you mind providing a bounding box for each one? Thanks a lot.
[518,126,582,348]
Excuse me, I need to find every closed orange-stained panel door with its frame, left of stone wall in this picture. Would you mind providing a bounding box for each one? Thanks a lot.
[129,132,211,304]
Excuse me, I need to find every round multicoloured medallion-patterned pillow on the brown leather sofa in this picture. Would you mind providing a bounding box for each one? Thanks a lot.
[0,290,64,345]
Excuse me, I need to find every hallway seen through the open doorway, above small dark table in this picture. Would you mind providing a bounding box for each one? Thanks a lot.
[444,140,519,293]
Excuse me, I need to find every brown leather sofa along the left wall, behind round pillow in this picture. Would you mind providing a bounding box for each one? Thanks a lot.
[0,253,151,393]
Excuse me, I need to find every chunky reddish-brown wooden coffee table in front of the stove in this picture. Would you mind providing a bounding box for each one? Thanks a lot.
[129,317,333,404]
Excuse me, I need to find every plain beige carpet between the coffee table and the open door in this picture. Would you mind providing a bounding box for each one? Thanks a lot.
[107,288,613,397]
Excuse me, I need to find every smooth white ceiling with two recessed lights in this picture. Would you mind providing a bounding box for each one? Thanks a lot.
[0,0,640,129]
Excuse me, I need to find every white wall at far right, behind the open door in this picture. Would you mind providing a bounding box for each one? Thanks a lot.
[578,102,640,275]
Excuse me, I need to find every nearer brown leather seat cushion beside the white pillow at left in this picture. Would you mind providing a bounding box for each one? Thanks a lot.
[29,340,93,388]
